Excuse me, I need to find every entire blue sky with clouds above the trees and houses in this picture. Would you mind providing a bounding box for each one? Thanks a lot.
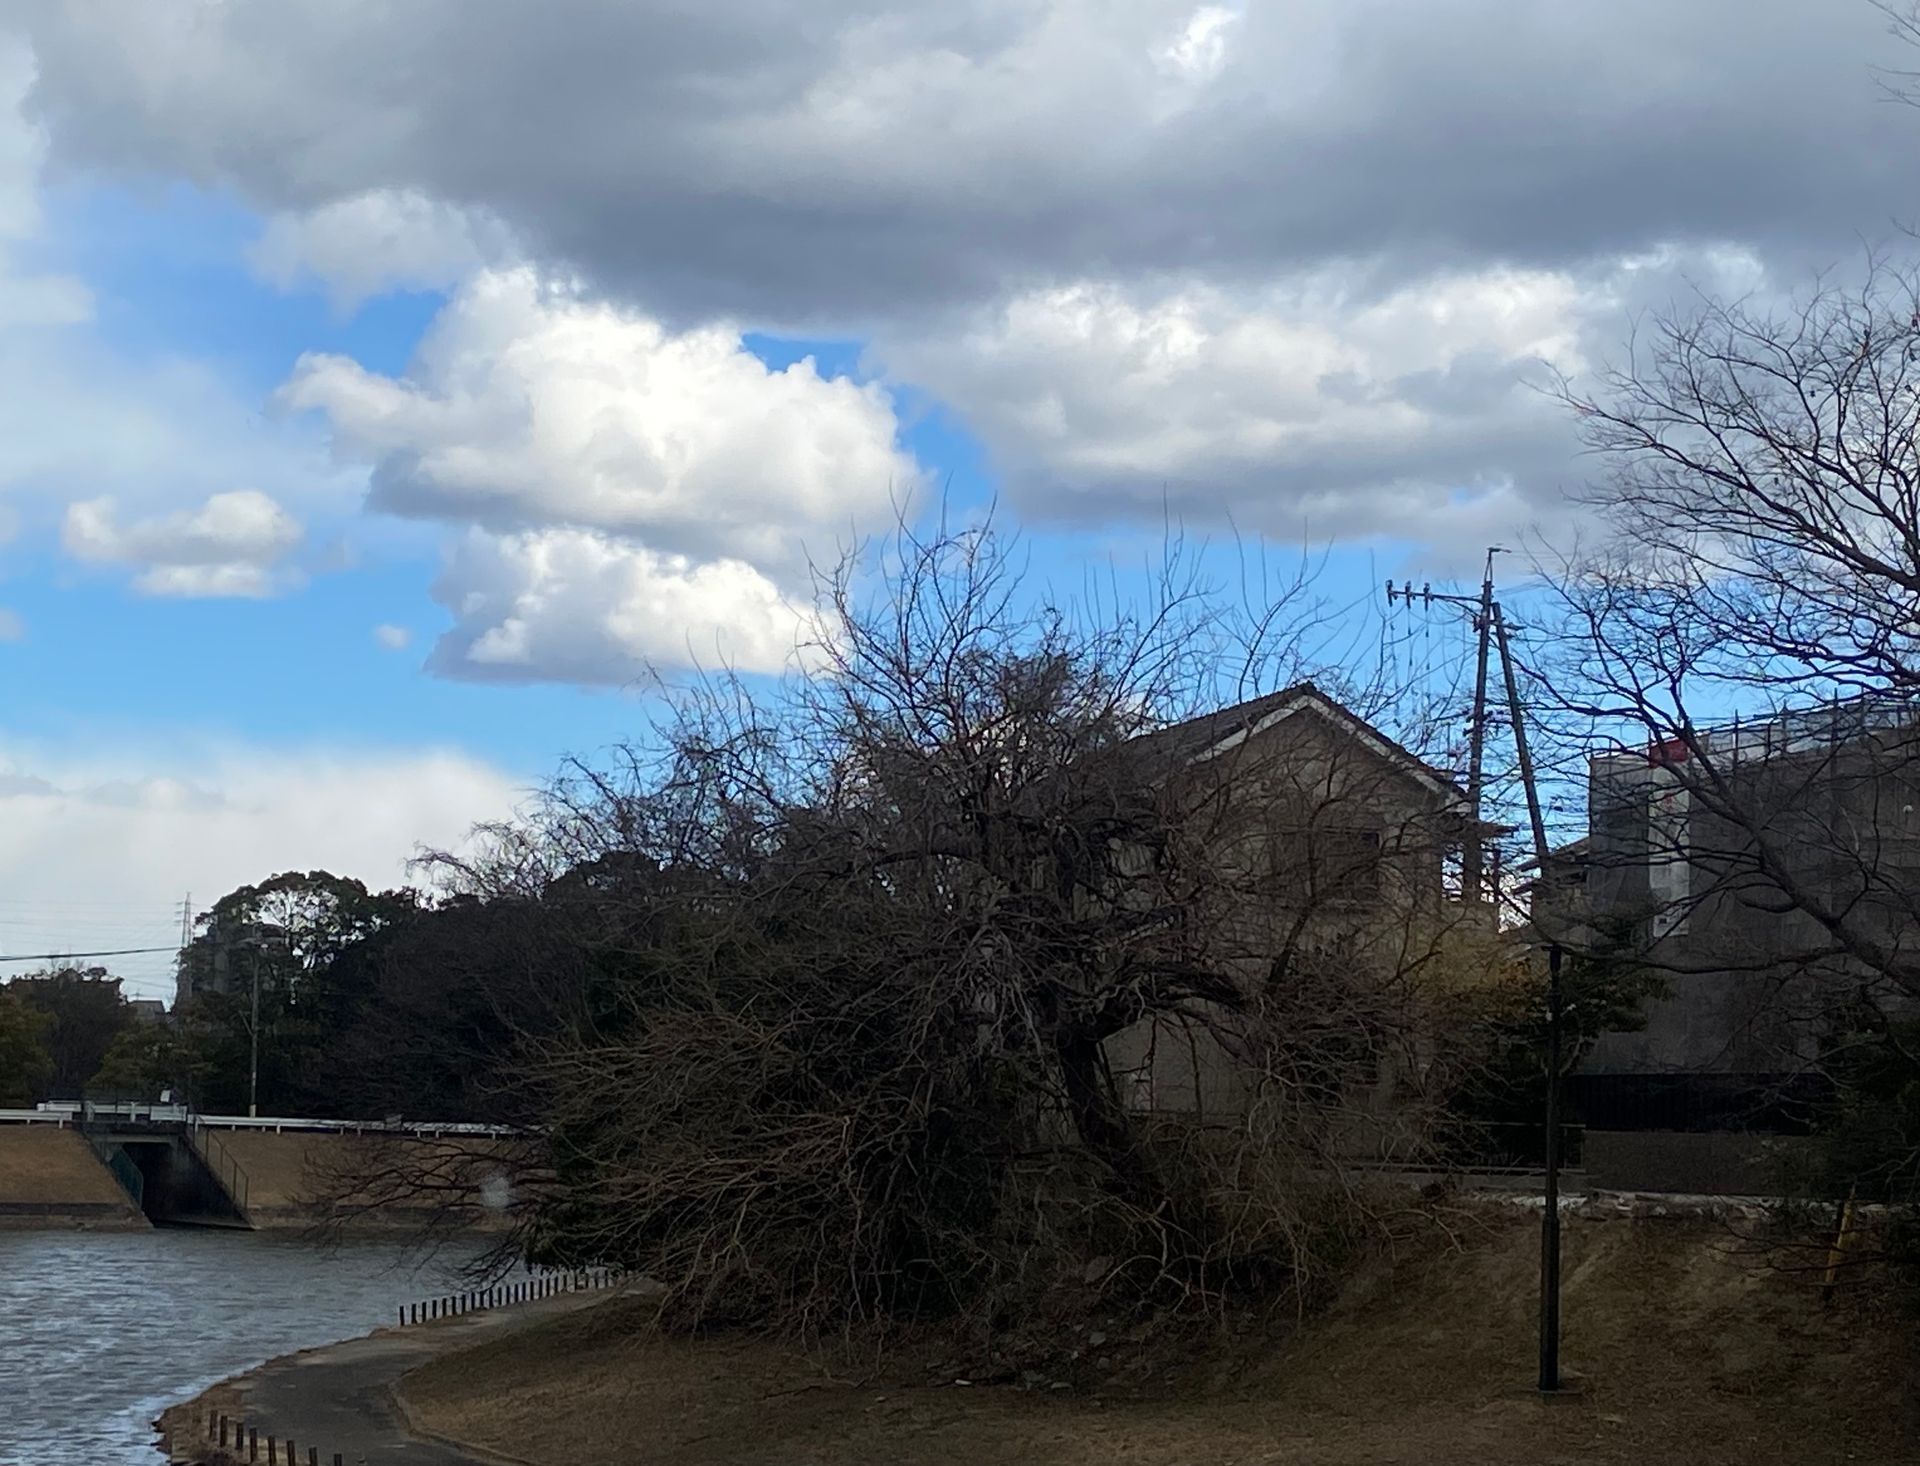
[0,0,1920,996]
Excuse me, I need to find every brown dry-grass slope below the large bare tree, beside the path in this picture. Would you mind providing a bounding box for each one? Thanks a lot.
[401,1213,1920,1466]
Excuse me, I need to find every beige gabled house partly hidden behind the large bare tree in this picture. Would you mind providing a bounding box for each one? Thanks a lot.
[1106,683,1494,1147]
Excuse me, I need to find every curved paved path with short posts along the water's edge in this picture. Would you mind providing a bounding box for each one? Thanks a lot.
[206,1291,609,1466]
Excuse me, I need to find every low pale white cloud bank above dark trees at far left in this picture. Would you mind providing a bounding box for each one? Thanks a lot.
[0,739,516,996]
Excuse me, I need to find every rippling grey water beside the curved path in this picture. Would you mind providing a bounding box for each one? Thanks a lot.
[0,1228,478,1466]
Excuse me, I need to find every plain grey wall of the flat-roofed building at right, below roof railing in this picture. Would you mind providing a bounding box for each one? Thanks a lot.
[1584,731,1920,1075]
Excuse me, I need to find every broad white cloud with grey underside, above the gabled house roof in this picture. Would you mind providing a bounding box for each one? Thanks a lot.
[876,269,1617,537]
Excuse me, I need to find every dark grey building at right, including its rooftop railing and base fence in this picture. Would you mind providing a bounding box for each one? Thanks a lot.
[1551,697,1920,1132]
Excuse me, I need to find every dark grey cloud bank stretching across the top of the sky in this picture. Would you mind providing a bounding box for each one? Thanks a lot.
[21,0,1920,322]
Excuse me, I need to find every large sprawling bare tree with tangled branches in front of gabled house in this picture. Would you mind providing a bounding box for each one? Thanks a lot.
[334,514,1498,1324]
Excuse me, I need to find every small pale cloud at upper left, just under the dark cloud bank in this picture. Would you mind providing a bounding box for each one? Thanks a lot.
[248,188,511,309]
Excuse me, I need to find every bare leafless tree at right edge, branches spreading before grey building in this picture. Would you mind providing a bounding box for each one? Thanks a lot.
[1540,261,1920,1228]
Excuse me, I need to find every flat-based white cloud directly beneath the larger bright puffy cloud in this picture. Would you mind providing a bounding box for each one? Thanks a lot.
[430,530,812,683]
